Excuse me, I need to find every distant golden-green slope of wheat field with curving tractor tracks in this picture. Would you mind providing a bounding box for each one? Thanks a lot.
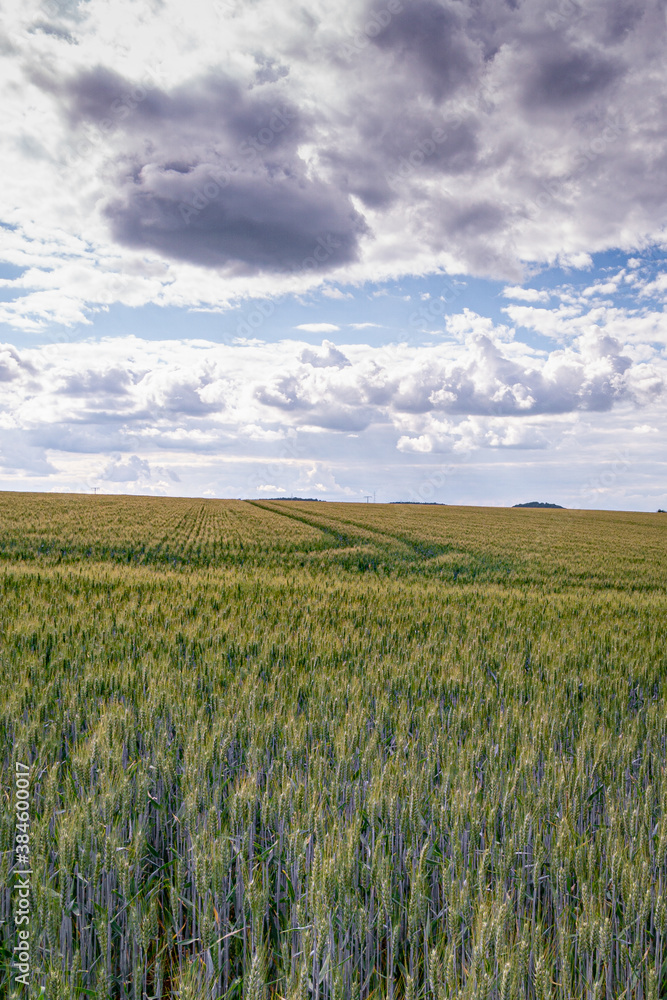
[0,493,667,590]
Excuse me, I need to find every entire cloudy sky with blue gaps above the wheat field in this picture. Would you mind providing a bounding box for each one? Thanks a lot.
[0,0,667,511]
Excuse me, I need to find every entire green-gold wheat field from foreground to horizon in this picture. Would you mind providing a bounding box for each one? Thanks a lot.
[0,493,667,1000]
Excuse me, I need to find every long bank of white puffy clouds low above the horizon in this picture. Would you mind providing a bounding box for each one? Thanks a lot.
[0,307,667,497]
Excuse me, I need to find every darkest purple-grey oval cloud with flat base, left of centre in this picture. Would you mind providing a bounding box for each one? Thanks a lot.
[105,163,367,274]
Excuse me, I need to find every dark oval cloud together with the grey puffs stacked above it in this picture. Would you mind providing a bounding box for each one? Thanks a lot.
[46,67,368,274]
